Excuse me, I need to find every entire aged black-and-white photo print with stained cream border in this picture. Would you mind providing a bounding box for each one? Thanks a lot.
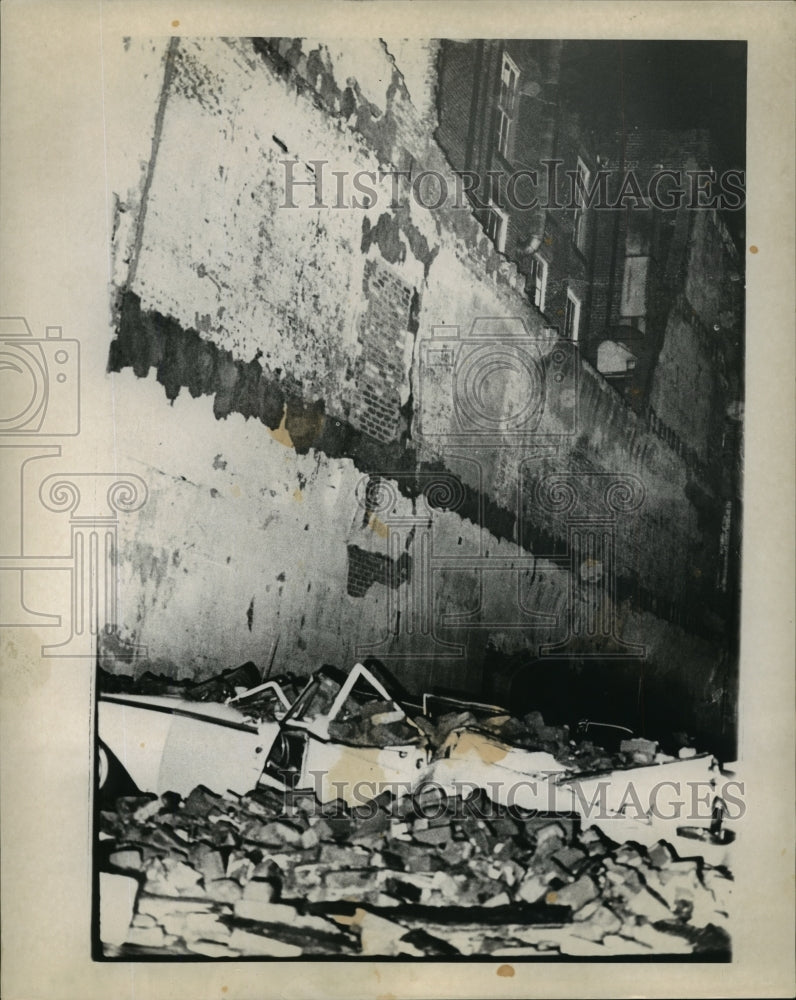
[0,4,793,1000]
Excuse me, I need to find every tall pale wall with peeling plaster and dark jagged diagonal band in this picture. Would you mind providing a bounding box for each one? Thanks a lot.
[106,39,728,752]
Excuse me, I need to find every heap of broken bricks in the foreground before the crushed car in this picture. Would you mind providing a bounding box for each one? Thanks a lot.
[99,786,732,958]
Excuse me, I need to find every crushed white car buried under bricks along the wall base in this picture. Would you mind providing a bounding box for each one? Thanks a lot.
[98,663,731,863]
